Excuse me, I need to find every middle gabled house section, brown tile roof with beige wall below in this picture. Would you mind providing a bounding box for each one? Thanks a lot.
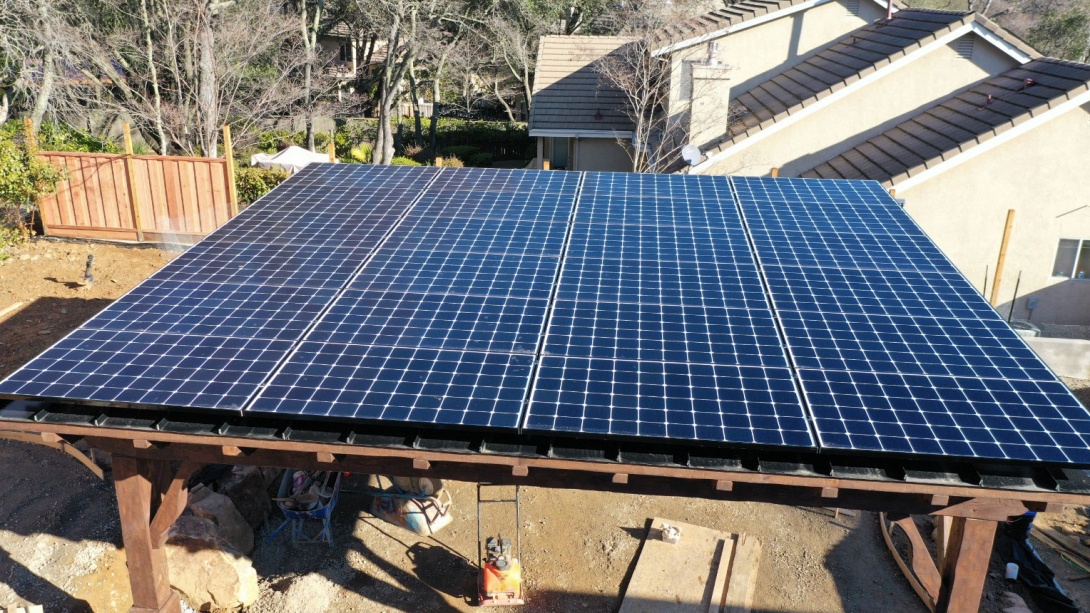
[692,9,1038,176]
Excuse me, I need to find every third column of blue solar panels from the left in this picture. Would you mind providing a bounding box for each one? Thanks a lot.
[525,173,813,447]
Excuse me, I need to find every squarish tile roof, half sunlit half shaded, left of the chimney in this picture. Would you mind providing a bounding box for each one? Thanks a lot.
[530,36,633,133]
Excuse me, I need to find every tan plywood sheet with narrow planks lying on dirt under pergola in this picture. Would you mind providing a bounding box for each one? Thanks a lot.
[619,517,760,613]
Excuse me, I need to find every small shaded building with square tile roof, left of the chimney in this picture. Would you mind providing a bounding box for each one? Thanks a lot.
[530,36,633,170]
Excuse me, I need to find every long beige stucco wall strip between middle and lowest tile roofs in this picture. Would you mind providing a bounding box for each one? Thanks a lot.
[705,34,1017,177]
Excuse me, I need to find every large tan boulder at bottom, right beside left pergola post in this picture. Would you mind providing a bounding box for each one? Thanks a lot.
[166,515,258,611]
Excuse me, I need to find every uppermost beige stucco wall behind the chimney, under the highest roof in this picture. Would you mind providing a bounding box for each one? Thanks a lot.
[669,0,885,122]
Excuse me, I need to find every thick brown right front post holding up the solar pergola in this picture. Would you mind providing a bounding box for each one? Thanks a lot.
[935,517,996,613]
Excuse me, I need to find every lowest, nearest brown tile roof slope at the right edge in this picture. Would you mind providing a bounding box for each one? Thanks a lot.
[802,58,1090,183]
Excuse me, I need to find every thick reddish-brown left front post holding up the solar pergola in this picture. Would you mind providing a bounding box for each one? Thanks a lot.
[113,456,182,613]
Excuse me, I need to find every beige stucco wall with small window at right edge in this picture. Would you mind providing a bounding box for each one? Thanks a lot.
[894,105,1090,325]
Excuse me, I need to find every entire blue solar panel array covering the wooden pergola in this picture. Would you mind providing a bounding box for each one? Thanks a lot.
[0,165,1090,465]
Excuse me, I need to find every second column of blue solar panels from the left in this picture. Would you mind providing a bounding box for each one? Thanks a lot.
[250,170,580,429]
